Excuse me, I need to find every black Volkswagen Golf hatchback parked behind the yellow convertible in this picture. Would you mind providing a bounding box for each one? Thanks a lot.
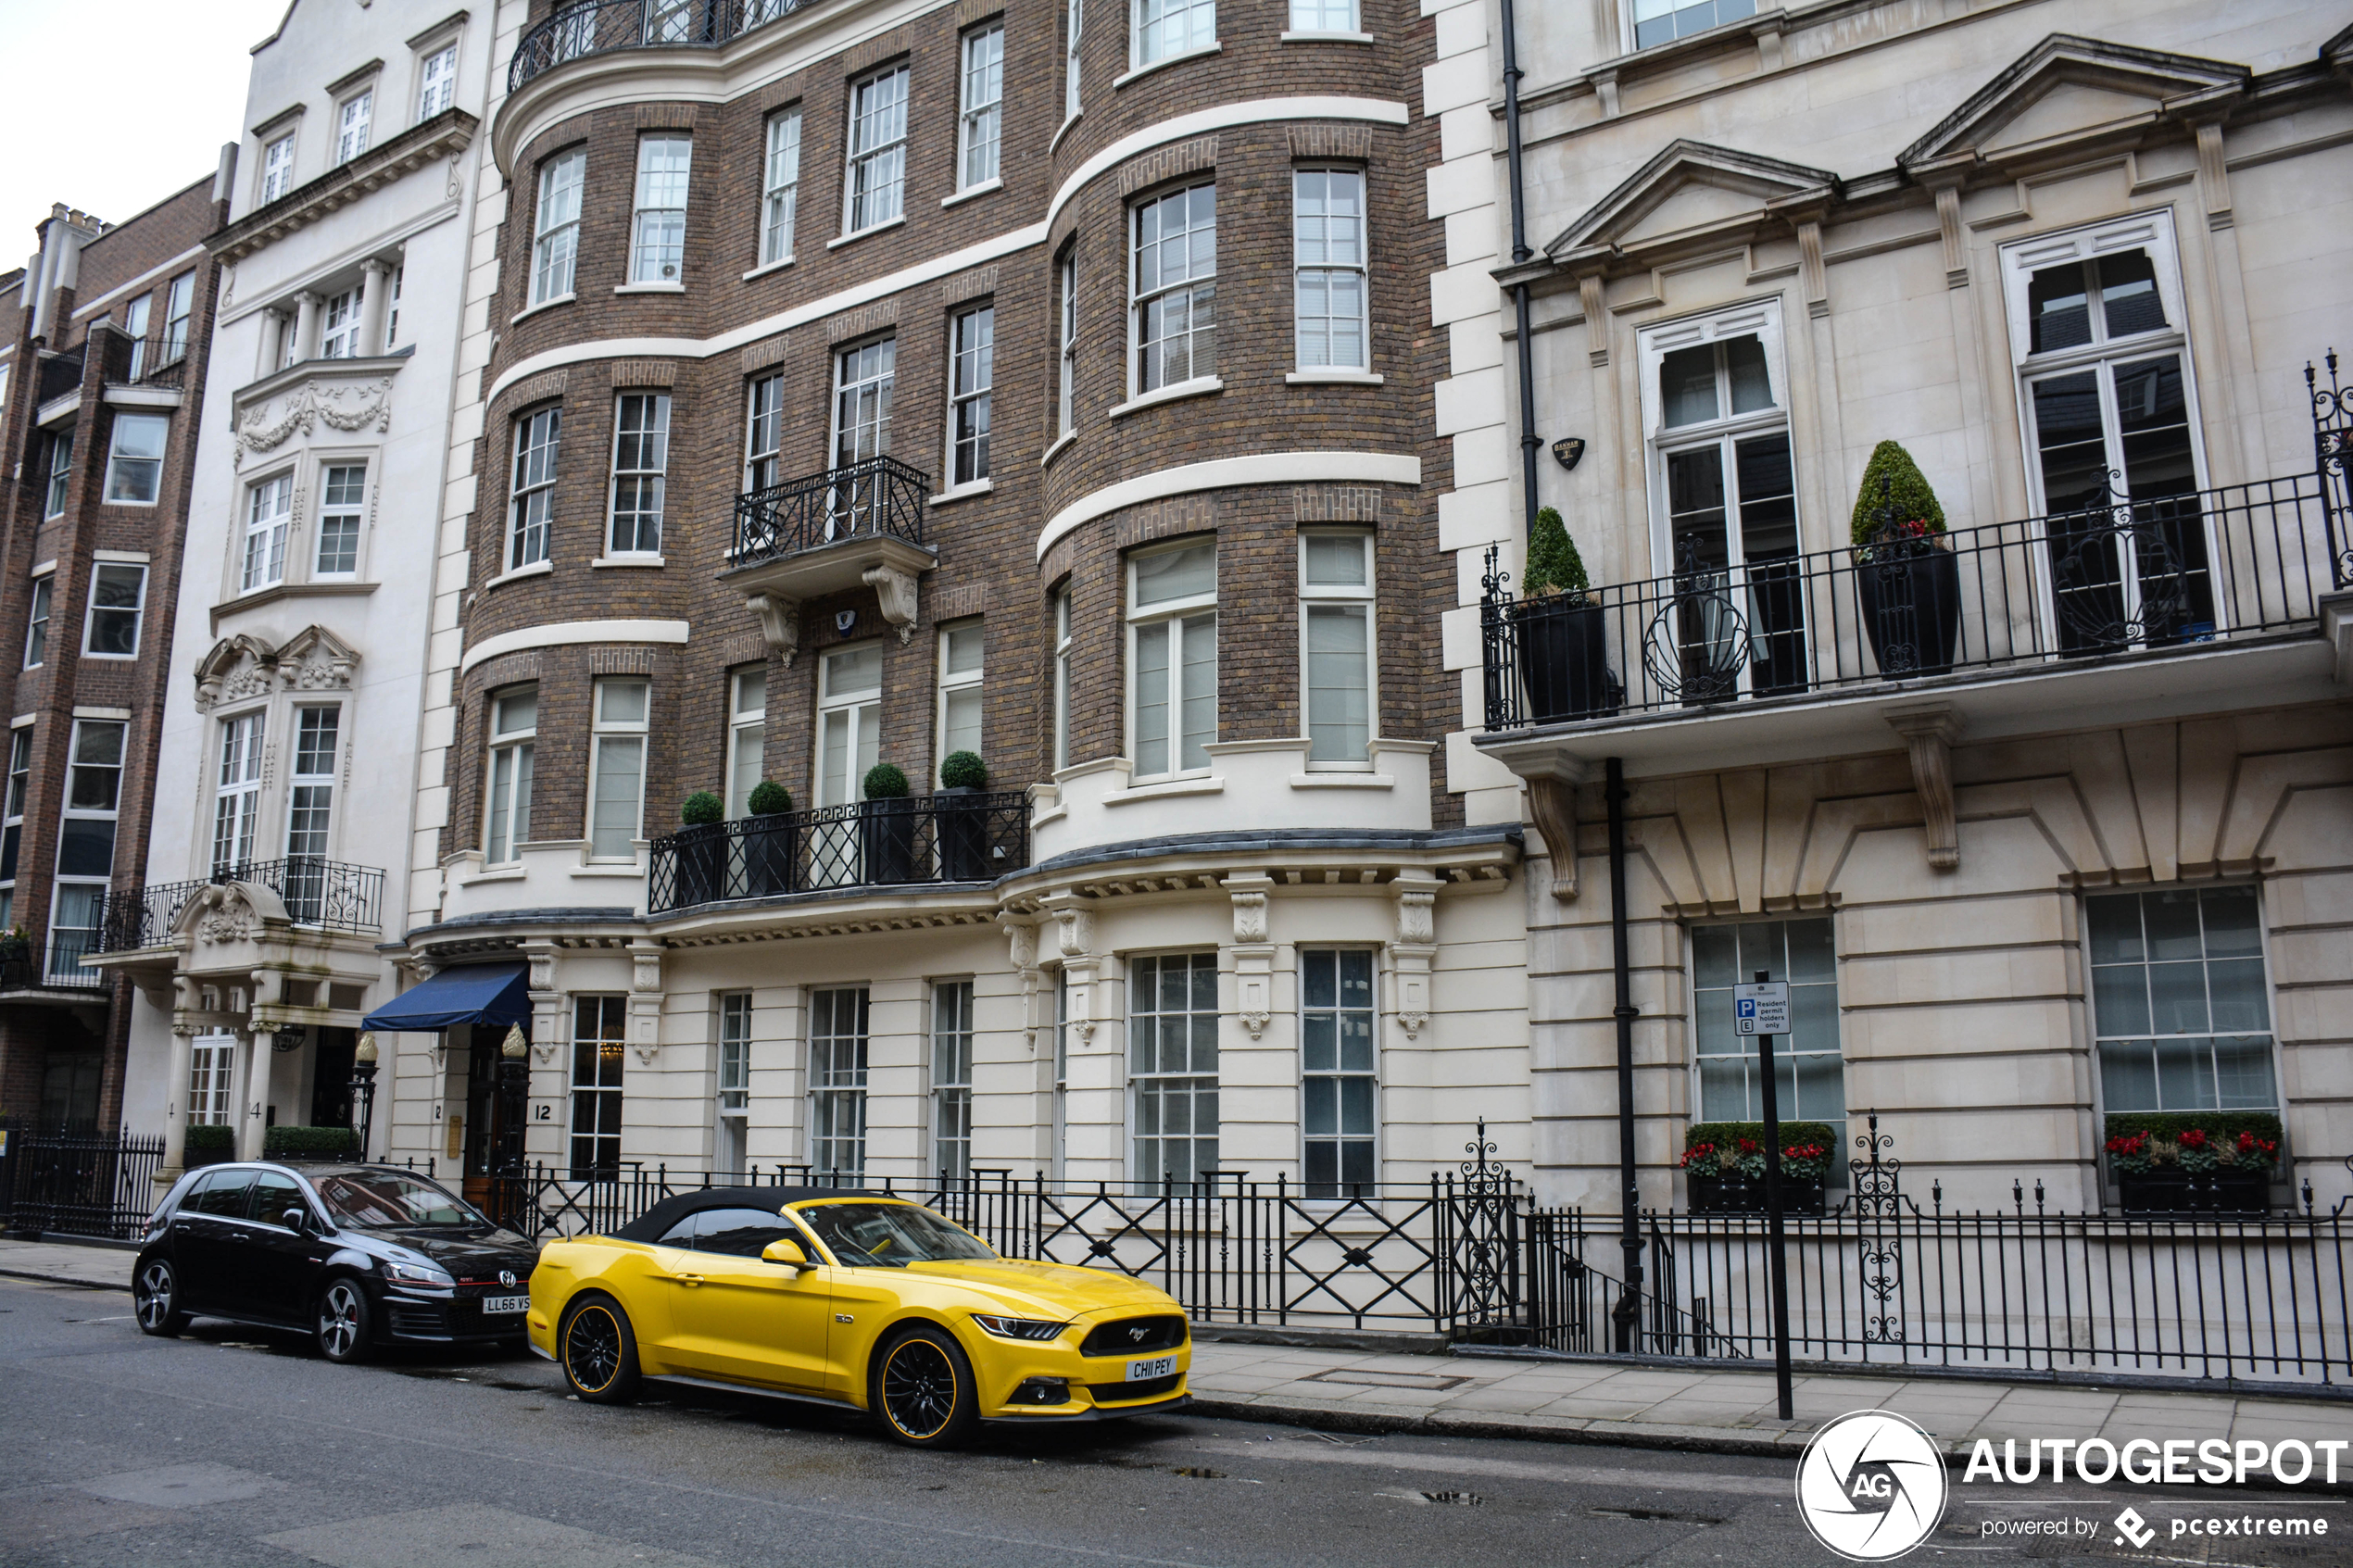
[132,1161,539,1361]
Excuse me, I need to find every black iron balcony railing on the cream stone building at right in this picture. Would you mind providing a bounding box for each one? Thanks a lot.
[1480,475,2346,729]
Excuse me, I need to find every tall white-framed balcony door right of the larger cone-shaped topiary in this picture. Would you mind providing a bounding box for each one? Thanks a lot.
[2005,214,2217,654]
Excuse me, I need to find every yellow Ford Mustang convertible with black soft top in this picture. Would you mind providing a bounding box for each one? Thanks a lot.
[530,1187,1193,1449]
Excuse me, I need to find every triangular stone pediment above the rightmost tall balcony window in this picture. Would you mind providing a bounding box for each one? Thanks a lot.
[1896,33,2252,169]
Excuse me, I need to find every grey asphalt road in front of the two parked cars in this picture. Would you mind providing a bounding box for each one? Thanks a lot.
[0,1279,2353,1568]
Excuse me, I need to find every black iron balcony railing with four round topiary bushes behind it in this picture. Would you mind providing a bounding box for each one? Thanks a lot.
[648,790,1028,914]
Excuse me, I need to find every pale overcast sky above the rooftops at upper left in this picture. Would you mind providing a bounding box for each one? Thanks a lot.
[0,0,287,270]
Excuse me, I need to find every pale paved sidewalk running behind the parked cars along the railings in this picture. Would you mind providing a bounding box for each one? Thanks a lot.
[0,1239,2353,1486]
